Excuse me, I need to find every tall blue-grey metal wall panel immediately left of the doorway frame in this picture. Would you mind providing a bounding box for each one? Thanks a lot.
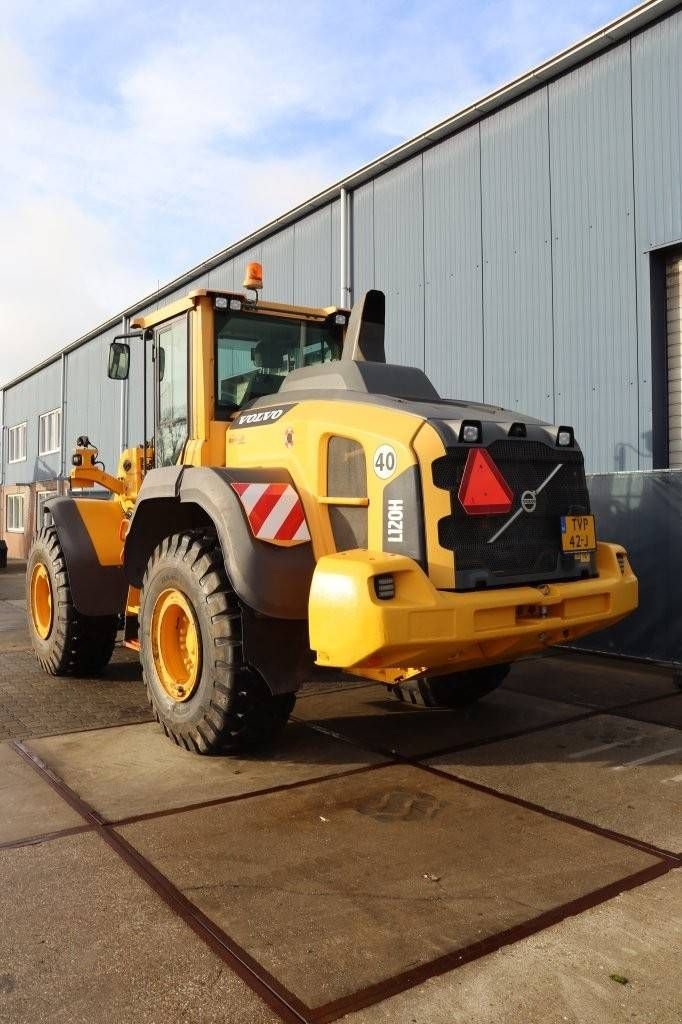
[549,43,639,470]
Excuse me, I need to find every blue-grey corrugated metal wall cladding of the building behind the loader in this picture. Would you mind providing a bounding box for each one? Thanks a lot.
[4,10,682,481]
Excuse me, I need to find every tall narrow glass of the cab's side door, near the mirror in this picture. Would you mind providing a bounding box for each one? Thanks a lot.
[155,316,189,466]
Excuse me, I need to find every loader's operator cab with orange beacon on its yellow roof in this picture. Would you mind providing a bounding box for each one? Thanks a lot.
[109,263,349,467]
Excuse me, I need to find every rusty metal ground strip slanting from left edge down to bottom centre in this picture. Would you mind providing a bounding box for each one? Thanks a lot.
[11,740,311,1024]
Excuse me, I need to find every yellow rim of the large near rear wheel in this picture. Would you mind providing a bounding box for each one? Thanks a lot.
[152,588,202,702]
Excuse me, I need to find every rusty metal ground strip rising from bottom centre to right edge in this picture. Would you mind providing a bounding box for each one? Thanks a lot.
[312,862,673,1024]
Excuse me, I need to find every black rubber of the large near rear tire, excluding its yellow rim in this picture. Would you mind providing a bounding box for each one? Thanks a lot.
[139,530,296,754]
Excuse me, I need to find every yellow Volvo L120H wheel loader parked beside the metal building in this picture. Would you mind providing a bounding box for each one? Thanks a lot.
[27,264,637,754]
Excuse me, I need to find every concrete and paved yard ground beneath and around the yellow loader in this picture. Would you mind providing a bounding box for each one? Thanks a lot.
[0,572,682,1024]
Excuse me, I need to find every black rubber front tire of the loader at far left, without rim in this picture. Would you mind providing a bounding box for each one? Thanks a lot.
[26,526,119,676]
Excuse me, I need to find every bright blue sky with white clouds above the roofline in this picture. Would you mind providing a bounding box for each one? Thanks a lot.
[0,0,626,382]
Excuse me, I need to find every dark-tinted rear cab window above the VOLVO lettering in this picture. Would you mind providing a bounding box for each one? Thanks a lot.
[215,311,341,413]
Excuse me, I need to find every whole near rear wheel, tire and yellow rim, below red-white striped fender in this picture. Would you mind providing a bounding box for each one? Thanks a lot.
[139,531,296,754]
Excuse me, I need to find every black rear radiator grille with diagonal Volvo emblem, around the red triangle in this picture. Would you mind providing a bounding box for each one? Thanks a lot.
[433,439,590,588]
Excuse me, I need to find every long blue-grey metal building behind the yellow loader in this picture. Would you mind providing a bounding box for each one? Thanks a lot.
[1,0,682,659]
